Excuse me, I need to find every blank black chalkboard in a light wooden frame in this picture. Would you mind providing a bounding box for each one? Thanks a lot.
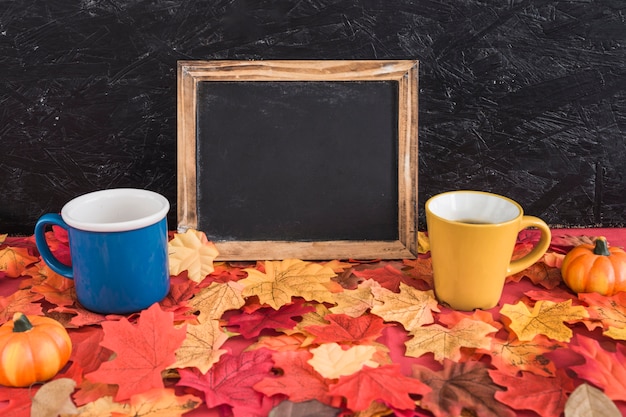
[177,60,418,260]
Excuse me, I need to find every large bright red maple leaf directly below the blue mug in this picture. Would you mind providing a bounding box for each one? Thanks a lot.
[85,303,186,401]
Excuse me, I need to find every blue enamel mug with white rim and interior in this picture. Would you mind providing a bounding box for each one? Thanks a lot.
[35,188,170,314]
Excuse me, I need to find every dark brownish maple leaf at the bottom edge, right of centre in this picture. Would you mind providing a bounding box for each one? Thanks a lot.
[413,359,515,417]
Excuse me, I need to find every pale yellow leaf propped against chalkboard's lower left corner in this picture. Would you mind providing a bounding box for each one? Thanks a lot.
[168,229,219,282]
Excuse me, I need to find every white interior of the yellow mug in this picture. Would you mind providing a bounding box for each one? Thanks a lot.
[427,191,522,224]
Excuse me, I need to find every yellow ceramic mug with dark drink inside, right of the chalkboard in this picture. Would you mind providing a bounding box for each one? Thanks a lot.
[426,191,551,311]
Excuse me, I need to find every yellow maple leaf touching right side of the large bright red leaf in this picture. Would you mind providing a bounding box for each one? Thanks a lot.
[170,320,228,374]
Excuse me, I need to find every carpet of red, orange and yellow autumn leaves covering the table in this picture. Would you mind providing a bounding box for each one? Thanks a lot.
[0,228,626,417]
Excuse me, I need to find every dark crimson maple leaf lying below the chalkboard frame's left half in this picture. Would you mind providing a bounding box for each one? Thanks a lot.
[228,300,315,339]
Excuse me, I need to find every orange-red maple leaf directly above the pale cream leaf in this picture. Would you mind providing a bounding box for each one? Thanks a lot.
[305,314,387,344]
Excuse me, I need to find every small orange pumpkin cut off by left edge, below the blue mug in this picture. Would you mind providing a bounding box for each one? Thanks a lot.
[0,313,72,387]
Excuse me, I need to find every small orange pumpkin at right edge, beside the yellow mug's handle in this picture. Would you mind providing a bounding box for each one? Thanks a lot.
[561,237,626,296]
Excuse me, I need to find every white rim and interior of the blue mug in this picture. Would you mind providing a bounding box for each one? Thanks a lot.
[61,188,170,232]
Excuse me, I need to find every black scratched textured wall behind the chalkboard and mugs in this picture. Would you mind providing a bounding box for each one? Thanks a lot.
[0,0,626,234]
